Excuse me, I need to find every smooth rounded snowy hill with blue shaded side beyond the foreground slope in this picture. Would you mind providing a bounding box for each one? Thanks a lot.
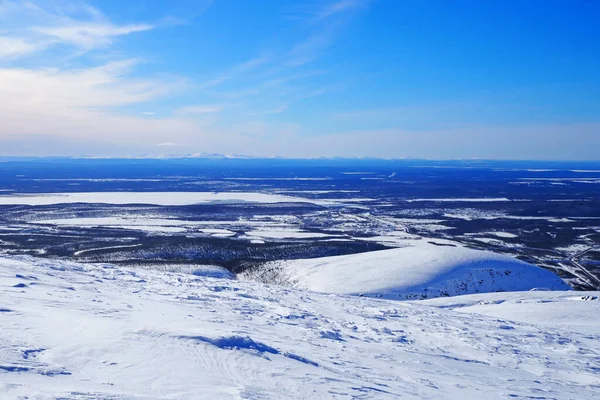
[245,244,570,299]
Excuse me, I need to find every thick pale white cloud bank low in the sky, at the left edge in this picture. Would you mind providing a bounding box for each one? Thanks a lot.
[0,60,190,147]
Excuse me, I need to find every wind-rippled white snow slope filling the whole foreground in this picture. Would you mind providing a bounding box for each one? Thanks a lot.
[0,258,600,400]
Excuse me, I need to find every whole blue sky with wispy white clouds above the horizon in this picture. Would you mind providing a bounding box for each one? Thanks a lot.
[0,0,600,160]
